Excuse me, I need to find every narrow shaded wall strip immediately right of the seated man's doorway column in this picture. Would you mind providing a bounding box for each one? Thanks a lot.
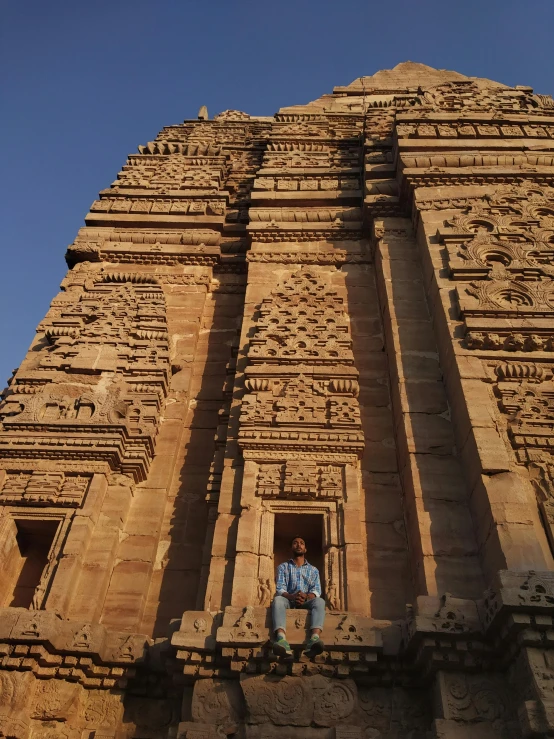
[342,264,412,620]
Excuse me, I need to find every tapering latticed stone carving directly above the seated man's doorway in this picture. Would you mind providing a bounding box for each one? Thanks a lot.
[240,269,362,460]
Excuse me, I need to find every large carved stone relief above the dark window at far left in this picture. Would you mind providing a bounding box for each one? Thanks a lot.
[0,275,169,480]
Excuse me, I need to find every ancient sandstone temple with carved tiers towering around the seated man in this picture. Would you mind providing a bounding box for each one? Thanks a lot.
[0,63,554,739]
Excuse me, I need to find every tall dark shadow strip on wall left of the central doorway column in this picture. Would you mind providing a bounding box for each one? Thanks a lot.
[154,284,244,637]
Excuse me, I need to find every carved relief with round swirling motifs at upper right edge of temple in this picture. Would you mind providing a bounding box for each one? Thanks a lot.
[439,182,554,352]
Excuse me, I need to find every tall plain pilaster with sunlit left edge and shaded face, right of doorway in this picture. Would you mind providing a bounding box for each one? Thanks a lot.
[376,219,484,598]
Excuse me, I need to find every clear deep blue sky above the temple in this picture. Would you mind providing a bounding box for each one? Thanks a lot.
[0,0,554,386]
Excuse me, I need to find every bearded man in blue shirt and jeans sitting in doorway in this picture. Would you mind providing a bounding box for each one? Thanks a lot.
[271,536,325,659]
